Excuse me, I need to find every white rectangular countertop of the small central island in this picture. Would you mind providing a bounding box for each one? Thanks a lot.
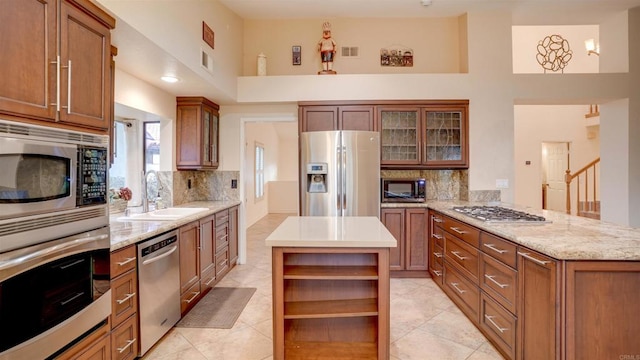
[265,216,397,248]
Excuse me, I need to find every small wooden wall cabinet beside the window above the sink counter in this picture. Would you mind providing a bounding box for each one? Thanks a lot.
[176,96,220,170]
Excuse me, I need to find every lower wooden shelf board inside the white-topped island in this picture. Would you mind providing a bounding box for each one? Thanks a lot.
[284,299,378,320]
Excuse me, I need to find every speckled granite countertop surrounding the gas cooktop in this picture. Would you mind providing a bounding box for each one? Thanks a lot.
[382,201,640,261]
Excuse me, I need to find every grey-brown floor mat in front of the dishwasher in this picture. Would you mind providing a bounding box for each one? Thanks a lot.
[176,287,256,329]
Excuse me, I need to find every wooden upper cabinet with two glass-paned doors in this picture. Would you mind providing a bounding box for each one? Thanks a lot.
[378,101,469,169]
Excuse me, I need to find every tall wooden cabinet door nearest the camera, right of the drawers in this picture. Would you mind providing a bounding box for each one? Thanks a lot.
[518,248,562,359]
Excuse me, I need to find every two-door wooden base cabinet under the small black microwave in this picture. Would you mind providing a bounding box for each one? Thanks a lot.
[380,208,429,277]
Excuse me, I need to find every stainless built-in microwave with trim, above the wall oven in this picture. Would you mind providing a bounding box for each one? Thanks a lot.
[0,120,109,253]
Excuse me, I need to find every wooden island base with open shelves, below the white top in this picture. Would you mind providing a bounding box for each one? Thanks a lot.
[272,247,389,360]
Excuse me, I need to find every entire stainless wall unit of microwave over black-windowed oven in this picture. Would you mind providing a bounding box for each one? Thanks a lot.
[0,120,111,360]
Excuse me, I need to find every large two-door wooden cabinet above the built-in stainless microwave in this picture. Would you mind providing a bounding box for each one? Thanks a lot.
[0,0,115,133]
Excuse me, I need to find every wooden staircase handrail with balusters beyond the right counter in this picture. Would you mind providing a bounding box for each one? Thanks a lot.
[564,158,600,218]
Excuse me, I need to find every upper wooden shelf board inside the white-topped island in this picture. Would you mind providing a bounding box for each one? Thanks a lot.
[283,265,378,280]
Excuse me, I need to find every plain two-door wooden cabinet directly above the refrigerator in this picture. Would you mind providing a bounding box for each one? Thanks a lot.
[299,103,376,132]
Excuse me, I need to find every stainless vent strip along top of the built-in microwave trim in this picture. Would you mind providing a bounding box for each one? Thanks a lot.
[0,121,109,146]
